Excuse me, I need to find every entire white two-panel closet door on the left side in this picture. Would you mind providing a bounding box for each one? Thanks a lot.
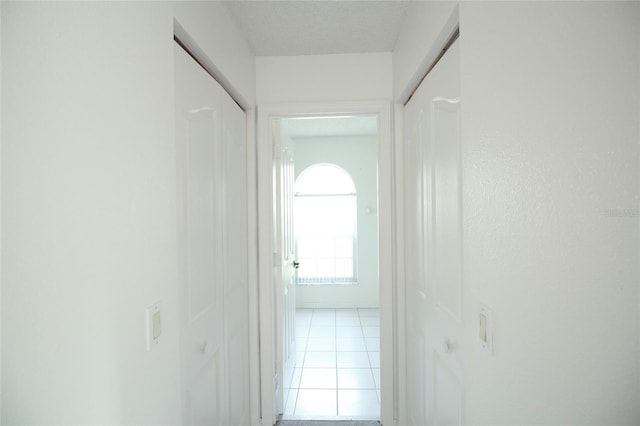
[174,40,249,425]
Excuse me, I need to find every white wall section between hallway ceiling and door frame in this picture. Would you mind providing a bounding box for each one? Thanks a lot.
[256,53,392,104]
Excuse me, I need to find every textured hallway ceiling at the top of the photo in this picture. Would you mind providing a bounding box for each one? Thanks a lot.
[224,0,409,56]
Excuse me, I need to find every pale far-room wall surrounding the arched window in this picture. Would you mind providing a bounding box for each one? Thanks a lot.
[293,136,380,308]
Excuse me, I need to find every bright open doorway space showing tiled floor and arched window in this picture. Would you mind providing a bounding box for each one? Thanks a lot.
[280,114,380,420]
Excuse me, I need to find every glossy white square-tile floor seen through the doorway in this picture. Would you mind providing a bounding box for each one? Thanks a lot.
[284,309,380,419]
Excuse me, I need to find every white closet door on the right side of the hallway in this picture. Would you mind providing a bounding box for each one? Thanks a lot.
[404,37,465,425]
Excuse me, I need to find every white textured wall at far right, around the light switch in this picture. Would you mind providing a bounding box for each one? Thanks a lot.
[394,2,640,425]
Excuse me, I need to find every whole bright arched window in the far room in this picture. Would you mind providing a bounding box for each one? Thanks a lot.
[294,164,356,284]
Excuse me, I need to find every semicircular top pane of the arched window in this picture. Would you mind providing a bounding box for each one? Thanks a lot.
[294,164,356,195]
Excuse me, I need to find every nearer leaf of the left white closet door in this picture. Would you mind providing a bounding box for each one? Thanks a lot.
[175,41,225,425]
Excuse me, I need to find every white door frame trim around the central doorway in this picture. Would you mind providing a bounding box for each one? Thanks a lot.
[252,101,398,426]
